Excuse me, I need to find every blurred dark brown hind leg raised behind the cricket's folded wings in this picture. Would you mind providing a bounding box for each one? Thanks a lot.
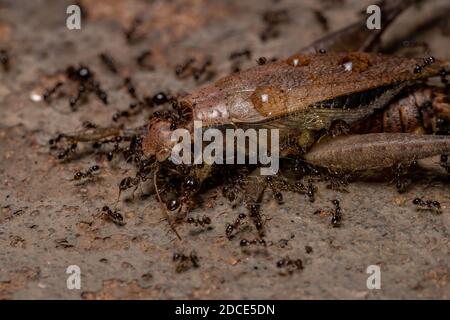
[299,0,419,54]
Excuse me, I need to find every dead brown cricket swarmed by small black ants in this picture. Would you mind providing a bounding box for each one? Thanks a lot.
[47,0,450,238]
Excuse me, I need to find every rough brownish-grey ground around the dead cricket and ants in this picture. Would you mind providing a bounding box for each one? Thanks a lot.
[0,0,450,299]
